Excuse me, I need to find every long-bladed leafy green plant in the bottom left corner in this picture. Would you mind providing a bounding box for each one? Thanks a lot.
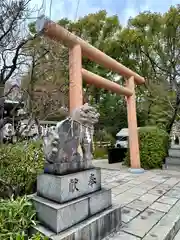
[0,196,47,240]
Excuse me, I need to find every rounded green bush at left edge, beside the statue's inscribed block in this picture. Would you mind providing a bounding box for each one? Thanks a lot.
[0,141,44,197]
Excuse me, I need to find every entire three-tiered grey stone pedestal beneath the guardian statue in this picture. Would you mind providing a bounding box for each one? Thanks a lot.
[32,168,121,240]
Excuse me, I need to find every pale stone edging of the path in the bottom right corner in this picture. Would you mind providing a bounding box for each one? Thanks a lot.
[143,201,180,240]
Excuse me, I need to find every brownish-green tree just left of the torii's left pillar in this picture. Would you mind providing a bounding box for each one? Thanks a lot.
[22,26,68,120]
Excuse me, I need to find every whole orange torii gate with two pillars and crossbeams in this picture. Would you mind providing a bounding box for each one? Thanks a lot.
[36,16,145,172]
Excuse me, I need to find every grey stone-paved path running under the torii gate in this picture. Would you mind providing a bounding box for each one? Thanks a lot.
[93,160,180,240]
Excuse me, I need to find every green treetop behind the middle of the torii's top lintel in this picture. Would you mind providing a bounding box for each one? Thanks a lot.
[58,10,122,104]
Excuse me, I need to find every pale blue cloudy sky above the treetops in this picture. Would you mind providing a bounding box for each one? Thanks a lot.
[30,0,179,25]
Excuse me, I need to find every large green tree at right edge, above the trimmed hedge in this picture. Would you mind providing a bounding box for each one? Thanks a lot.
[116,5,180,133]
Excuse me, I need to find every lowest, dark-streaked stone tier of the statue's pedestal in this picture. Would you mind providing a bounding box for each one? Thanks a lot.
[31,202,121,240]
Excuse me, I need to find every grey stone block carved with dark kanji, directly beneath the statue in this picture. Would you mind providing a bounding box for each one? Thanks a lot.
[37,168,101,203]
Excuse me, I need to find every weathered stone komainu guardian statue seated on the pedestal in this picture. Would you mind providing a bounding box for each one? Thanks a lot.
[43,103,99,174]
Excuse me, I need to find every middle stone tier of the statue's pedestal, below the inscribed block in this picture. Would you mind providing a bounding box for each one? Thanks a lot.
[32,189,111,233]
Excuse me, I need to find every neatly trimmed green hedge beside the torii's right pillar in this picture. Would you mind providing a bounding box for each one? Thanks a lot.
[125,127,169,169]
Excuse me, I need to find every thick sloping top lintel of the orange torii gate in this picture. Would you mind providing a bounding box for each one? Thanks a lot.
[36,16,145,84]
